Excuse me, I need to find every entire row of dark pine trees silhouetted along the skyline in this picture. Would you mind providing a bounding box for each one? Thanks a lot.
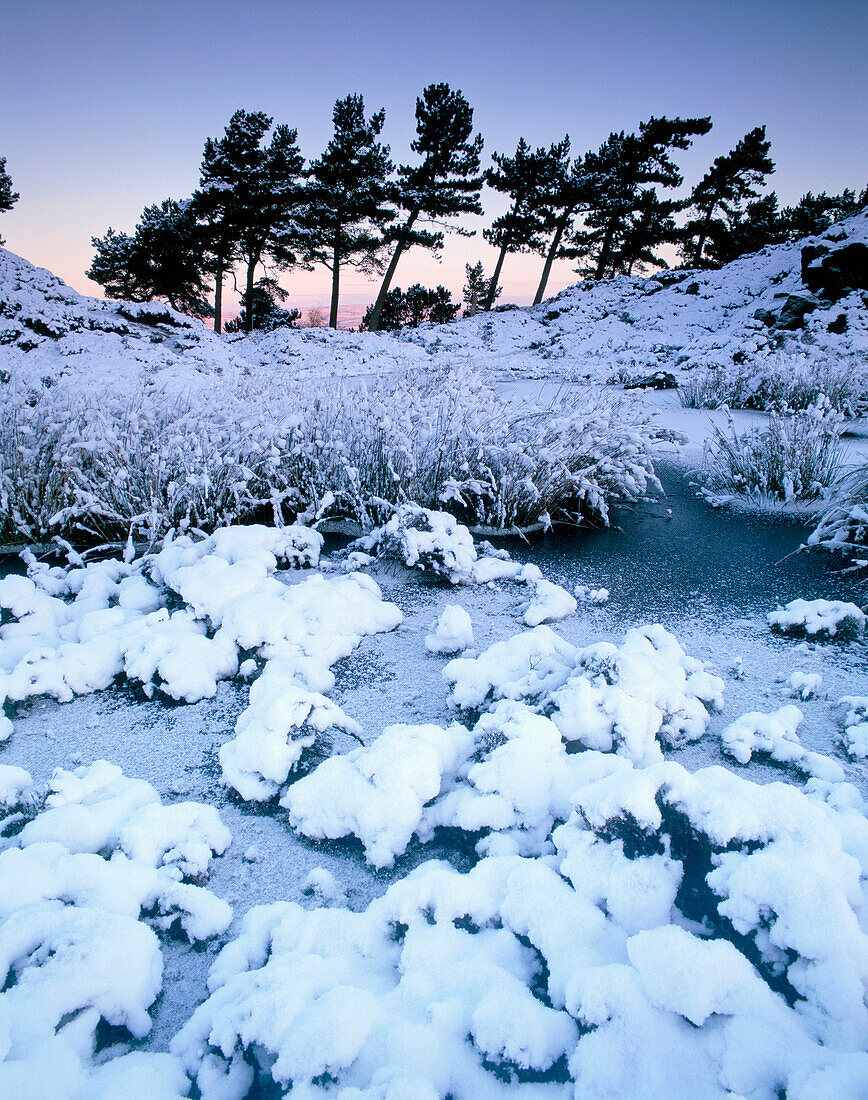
[0,97,868,332]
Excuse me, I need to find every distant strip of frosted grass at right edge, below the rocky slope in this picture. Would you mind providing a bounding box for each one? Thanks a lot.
[678,355,868,416]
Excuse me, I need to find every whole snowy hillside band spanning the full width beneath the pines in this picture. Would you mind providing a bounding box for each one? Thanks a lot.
[0,213,868,389]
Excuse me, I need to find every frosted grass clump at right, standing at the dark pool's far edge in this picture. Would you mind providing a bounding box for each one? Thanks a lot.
[702,399,842,502]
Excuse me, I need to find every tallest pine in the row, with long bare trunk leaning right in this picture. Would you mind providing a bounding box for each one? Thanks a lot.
[363,84,483,331]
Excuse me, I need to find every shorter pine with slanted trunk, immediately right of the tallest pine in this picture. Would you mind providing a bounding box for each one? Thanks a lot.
[483,138,563,309]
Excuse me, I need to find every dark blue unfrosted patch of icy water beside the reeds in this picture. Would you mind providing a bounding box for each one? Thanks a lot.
[510,461,868,624]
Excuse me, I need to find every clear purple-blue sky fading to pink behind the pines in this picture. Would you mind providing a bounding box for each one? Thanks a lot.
[0,0,868,321]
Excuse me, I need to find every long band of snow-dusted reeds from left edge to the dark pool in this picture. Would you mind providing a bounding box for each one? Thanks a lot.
[0,366,671,542]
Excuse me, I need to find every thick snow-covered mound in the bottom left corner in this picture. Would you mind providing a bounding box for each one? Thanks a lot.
[0,760,232,1100]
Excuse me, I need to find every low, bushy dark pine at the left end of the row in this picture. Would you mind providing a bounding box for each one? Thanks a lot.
[86,199,211,317]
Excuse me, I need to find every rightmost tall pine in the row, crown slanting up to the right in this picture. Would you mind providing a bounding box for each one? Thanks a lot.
[682,127,774,267]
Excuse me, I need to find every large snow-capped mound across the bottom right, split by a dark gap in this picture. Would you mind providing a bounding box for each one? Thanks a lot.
[173,748,868,1100]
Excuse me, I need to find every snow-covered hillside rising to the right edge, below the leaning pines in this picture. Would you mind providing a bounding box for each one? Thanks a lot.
[385,213,868,381]
